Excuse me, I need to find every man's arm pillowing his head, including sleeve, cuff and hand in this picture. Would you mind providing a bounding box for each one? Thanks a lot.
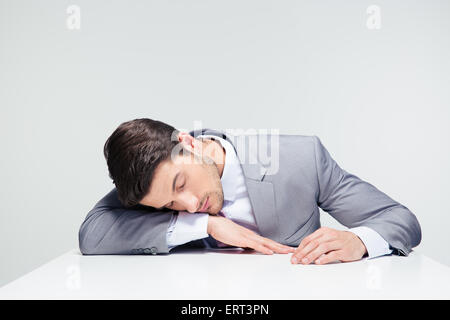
[79,188,293,255]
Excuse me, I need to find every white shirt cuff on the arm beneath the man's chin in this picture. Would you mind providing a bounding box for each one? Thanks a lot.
[167,211,209,250]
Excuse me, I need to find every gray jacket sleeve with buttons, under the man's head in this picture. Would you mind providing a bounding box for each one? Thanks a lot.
[78,188,176,255]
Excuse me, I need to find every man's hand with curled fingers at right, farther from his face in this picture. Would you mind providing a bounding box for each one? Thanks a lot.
[291,227,367,264]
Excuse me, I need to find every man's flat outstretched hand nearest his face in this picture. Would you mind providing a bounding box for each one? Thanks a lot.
[208,215,295,254]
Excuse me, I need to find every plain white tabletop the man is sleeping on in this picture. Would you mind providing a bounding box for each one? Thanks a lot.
[0,249,450,300]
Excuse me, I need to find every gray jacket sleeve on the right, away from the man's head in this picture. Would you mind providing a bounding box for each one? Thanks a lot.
[313,136,422,256]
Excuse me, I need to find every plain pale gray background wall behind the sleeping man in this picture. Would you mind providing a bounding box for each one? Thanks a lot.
[0,0,450,285]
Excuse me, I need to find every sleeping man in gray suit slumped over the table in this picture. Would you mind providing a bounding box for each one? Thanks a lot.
[79,118,421,264]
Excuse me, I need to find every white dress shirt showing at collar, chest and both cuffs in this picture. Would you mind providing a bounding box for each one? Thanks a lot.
[167,135,392,258]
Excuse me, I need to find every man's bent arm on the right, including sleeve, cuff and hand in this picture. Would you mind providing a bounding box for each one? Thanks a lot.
[292,136,421,263]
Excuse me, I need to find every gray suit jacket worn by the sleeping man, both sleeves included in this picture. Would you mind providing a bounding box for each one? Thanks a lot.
[79,129,421,255]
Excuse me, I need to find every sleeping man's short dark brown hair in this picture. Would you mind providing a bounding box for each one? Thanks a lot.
[103,118,179,207]
